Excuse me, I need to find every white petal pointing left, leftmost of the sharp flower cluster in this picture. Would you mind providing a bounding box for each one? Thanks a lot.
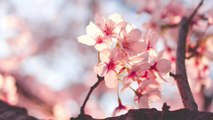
[77,35,96,46]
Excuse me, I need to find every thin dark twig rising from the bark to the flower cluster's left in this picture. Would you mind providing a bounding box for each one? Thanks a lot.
[80,75,104,114]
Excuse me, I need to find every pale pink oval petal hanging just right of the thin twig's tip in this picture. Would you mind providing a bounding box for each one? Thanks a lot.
[104,70,118,88]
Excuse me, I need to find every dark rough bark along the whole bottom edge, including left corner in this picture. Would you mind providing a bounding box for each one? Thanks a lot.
[0,101,213,120]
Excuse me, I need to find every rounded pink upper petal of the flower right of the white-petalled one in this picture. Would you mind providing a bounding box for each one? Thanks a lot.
[128,29,141,41]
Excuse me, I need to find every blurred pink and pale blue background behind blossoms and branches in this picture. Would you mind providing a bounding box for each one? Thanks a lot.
[0,0,213,120]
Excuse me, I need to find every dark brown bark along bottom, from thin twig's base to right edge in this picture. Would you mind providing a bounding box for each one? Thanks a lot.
[70,108,213,120]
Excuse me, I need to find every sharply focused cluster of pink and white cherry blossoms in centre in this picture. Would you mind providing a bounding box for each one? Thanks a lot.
[78,14,171,107]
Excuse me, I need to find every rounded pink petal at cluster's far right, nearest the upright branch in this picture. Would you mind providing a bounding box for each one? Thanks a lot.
[156,59,172,73]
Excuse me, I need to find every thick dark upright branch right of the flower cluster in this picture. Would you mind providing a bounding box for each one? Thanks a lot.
[176,0,203,110]
